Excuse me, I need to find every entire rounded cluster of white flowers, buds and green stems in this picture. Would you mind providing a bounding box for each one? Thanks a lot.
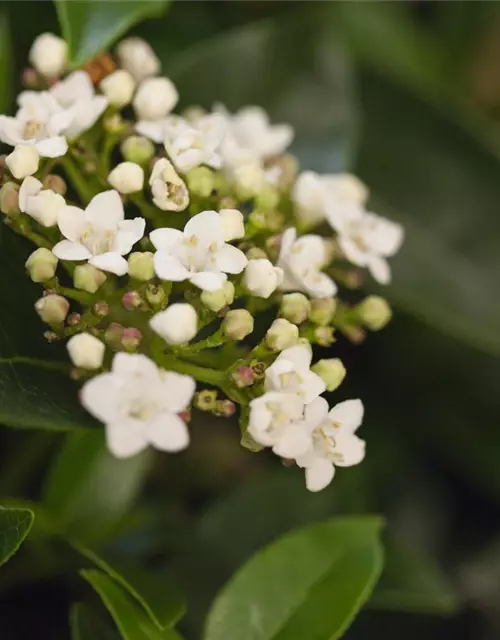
[0,34,403,491]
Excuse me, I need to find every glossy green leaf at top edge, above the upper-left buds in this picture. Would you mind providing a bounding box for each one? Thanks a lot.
[54,0,169,66]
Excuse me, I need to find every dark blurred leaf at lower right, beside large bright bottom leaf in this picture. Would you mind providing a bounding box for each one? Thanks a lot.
[369,538,459,615]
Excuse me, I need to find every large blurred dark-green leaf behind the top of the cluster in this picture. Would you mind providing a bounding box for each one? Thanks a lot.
[170,11,357,169]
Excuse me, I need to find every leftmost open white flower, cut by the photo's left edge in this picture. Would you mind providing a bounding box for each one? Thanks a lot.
[0,91,72,158]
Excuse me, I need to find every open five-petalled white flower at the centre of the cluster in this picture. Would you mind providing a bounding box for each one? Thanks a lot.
[150,211,248,291]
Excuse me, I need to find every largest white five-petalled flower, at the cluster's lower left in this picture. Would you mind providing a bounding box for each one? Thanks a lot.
[80,353,195,458]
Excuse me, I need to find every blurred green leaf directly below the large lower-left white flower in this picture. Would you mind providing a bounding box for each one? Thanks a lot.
[44,431,151,544]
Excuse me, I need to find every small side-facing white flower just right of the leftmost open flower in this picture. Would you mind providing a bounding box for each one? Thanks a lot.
[50,71,108,138]
